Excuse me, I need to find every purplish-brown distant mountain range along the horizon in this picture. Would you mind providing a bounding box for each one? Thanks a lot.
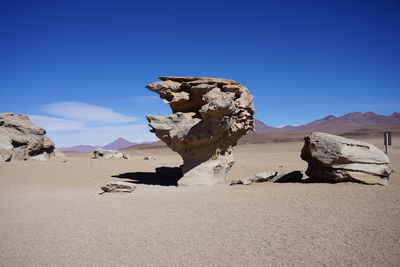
[59,112,400,152]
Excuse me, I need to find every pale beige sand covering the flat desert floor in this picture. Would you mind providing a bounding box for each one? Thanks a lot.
[0,139,400,266]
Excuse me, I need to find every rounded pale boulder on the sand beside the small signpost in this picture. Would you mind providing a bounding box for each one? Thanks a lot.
[301,132,391,185]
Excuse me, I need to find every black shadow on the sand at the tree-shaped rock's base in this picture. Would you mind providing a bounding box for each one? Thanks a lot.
[112,167,183,186]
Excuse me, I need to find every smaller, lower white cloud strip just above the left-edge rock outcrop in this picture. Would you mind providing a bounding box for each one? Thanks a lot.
[28,115,85,132]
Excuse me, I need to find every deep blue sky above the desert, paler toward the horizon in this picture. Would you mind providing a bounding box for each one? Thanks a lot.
[0,0,400,145]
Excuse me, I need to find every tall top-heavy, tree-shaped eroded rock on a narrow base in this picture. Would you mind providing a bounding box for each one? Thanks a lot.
[146,77,254,185]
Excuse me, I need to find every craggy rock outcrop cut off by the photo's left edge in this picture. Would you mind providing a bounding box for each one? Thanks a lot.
[0,112,62,161]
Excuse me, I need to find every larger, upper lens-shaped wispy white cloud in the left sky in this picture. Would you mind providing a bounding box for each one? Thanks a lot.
[42,102,137,124]
